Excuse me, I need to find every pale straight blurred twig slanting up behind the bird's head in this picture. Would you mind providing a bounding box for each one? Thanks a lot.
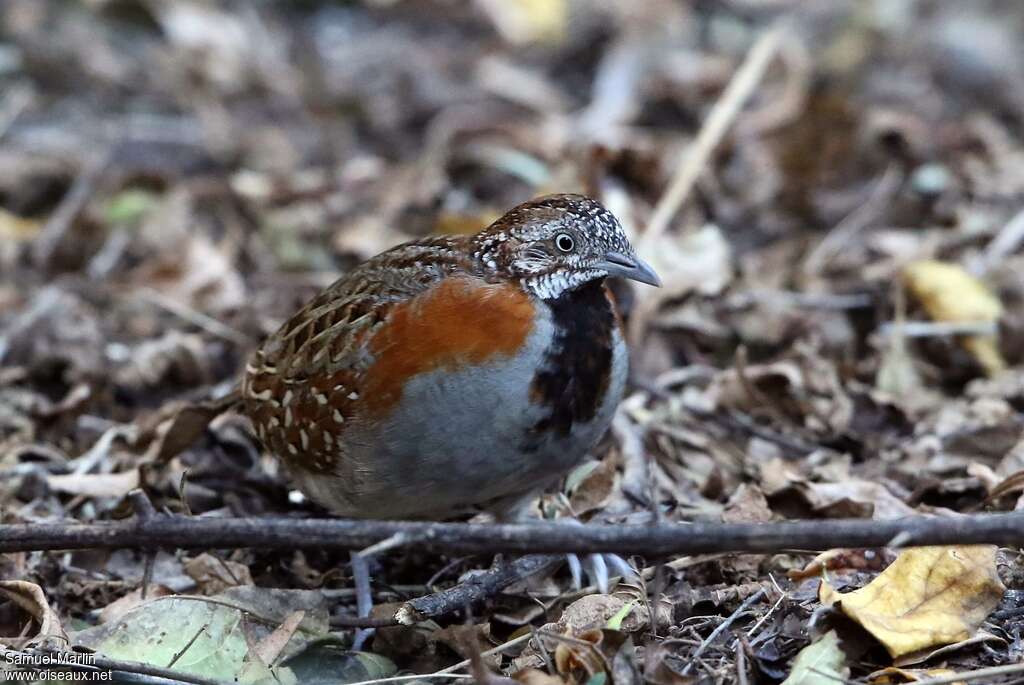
[641,26,783,252]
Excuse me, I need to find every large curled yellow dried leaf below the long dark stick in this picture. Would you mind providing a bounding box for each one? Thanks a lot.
[820,545,1006,658]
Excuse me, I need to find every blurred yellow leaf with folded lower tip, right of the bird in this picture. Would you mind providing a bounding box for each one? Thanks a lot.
[903,260,1006,376]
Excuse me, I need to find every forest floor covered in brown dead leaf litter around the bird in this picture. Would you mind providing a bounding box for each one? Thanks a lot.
[0,0,1024,685]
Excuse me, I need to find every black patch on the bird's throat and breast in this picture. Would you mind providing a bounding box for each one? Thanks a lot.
[524,281,617,449]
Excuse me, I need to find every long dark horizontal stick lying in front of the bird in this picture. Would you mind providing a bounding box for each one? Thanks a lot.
[0,513,1024,557]
